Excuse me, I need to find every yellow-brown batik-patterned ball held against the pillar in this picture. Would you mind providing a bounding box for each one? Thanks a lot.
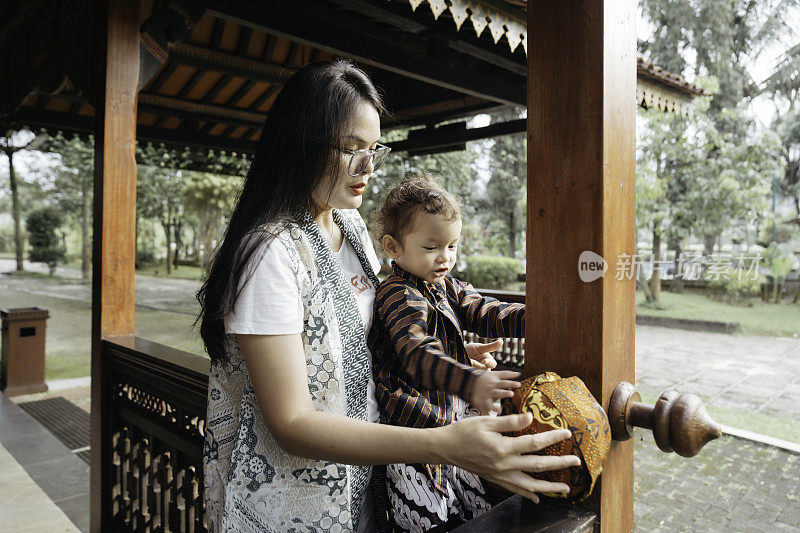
[503,372,611,501]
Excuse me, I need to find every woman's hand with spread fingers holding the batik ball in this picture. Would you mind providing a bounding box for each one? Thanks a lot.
[441,413,580,503]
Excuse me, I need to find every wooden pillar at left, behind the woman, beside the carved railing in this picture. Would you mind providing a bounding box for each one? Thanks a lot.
[90,0,139,532]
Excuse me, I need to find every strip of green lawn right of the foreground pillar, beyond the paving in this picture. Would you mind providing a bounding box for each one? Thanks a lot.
[636,291,800,337]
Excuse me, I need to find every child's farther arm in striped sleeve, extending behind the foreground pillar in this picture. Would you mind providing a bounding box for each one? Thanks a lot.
[450,278,525,338]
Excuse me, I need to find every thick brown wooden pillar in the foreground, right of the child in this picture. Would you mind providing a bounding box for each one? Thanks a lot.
[525,0,636,533]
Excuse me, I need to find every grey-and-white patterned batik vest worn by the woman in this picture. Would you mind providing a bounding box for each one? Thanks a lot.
[203,211,378,533]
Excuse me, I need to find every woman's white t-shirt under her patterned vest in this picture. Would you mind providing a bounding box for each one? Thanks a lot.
[225,237,380,422]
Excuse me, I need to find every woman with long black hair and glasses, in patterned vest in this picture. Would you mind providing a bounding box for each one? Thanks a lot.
[198,60,578,532]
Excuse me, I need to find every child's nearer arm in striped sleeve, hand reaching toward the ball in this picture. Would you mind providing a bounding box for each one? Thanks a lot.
[375,284,519,414]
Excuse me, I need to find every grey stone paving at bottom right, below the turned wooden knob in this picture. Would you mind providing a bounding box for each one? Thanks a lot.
[634,432,800,533]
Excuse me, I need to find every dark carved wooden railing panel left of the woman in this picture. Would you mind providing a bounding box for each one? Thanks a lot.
[101,337,209,532]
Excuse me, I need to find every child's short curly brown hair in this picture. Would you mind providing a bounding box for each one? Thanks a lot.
[374,174,461,242]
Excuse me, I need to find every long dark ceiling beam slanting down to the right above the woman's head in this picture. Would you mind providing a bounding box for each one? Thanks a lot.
[209,0,526,105]
